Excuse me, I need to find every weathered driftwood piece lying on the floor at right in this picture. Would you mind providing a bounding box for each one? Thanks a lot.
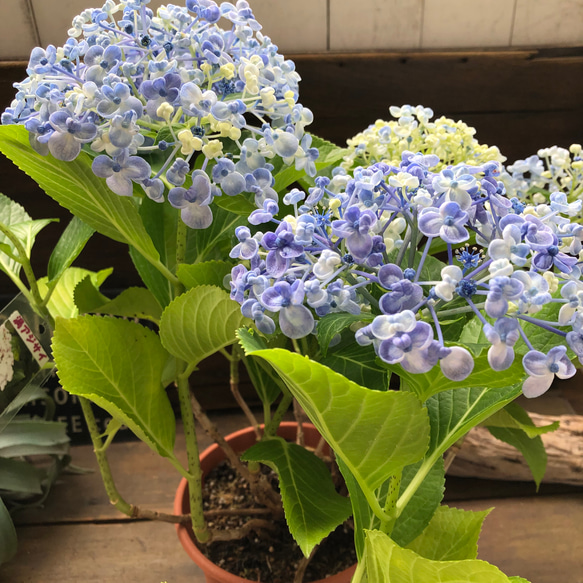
[448,413,583,486]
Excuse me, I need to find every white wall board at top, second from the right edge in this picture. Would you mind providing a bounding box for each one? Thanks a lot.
[421,0,516,49]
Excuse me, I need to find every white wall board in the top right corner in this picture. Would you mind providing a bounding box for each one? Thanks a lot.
[512,0,583,47]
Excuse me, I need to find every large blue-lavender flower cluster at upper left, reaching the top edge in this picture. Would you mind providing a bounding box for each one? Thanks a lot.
[2,0,318,228]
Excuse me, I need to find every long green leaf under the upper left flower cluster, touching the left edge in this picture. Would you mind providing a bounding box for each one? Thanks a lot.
[0,124,159,262]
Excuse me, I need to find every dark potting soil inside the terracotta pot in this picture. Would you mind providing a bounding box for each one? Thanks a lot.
[200,462,356,583]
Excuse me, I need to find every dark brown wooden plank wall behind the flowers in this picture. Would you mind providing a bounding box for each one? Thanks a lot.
[0,48,583,295]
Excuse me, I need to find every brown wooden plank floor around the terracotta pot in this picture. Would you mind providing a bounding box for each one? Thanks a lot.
[0,412,583,583]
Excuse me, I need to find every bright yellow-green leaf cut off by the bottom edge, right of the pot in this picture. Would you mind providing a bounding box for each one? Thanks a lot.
[364,530,509,583]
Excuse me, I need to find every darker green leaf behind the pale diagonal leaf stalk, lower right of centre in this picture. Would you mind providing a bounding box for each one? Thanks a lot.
[391,457,445,547]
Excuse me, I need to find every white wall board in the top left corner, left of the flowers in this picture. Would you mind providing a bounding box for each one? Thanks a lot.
[0,0,36,61]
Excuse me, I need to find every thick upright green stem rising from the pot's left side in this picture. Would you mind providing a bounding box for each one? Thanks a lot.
[176,360,210,543]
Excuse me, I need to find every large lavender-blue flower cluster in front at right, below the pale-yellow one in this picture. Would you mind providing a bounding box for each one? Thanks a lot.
[231,152,583,397]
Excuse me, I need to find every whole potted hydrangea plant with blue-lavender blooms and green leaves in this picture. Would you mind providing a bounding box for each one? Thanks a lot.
[0,0,583,583]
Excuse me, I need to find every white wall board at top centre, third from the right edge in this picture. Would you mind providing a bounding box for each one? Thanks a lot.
[330,0,423,51]
